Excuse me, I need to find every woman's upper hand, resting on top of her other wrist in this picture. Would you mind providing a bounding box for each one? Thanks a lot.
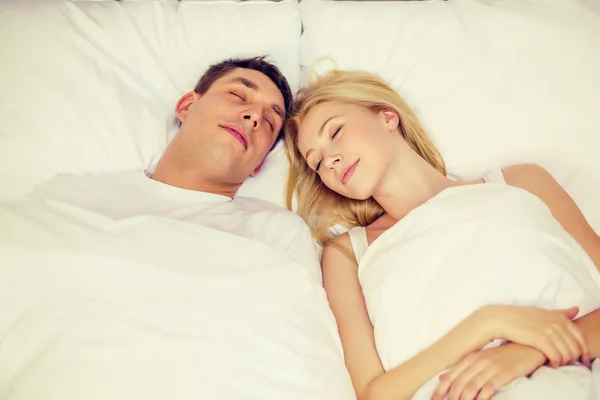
[476,305,590,367]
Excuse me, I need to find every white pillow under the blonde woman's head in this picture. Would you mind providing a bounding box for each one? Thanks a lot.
[300,0,600,231]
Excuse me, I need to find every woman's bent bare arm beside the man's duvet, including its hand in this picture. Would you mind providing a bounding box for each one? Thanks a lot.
[322,236,580,400]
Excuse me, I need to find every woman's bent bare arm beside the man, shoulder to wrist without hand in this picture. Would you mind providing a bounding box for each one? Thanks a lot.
[322,237,500,400]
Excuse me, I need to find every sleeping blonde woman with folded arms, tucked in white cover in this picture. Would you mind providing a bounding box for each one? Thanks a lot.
[286,71,600,399]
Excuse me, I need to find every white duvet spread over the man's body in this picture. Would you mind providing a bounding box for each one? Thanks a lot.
[0,201,354,400]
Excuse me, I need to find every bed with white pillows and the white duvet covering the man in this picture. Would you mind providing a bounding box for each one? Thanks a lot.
[0,0,600,400]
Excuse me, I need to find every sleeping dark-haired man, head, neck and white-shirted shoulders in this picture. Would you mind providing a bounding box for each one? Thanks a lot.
[21,57,312,262]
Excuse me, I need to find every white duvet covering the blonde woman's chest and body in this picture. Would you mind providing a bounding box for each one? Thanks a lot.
[359,183,600,400]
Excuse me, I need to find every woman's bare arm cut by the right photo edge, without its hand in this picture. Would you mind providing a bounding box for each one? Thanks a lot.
[503,164,600,358]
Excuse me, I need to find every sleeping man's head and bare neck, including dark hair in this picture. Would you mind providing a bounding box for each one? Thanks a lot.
[152,58,292,197]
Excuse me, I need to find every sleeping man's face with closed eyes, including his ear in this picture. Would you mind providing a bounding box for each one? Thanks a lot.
[176,68,285,184]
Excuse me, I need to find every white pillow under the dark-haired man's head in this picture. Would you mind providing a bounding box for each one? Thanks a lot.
[0,0,301,202]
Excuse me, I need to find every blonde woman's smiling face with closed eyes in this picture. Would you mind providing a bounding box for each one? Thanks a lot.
[298,102,402,200]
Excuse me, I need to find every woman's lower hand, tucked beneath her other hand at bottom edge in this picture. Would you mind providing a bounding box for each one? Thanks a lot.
[431,343,546,400]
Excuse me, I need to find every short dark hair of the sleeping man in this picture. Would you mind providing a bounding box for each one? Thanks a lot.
[194,56,293,145]
